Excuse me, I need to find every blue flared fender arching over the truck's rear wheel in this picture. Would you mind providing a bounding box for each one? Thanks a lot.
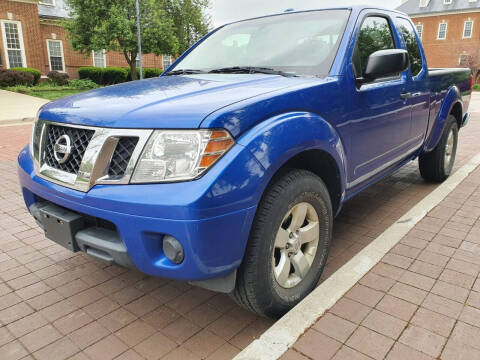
[423,86,463,152]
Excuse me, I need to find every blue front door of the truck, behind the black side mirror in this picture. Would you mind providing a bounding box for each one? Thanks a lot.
[340,13,412,189]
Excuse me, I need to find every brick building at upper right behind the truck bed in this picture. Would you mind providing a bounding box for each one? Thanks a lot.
[398,0,480,81]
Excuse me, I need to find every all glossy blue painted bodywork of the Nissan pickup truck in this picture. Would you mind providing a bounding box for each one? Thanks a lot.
[18,7,470,280]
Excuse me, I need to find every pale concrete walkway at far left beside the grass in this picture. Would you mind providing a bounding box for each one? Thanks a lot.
[0,90,48,125]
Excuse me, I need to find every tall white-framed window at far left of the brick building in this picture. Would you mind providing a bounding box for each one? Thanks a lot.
[1,20,27,68]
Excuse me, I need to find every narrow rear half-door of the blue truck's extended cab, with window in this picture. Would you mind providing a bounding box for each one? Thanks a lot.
[396,17,430,143]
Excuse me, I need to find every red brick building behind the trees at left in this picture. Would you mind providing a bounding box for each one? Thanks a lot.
[0,0,172,77]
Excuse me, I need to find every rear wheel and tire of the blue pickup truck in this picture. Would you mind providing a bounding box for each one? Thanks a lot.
[418,115,458,182]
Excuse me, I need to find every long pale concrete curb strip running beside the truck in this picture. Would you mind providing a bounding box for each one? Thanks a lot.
[234,153,480,360]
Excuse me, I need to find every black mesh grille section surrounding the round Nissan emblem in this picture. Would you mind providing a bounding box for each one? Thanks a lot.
[44,125,95,174]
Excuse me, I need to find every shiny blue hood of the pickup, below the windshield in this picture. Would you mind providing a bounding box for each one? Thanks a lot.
[39,74,299,129]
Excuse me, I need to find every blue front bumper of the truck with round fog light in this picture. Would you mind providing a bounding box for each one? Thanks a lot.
[18,145,264,281]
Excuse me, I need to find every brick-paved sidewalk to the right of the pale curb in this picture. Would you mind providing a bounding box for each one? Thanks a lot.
[282,168,480,360]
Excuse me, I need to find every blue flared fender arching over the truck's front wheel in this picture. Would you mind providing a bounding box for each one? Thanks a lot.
[238,112,346,207]
